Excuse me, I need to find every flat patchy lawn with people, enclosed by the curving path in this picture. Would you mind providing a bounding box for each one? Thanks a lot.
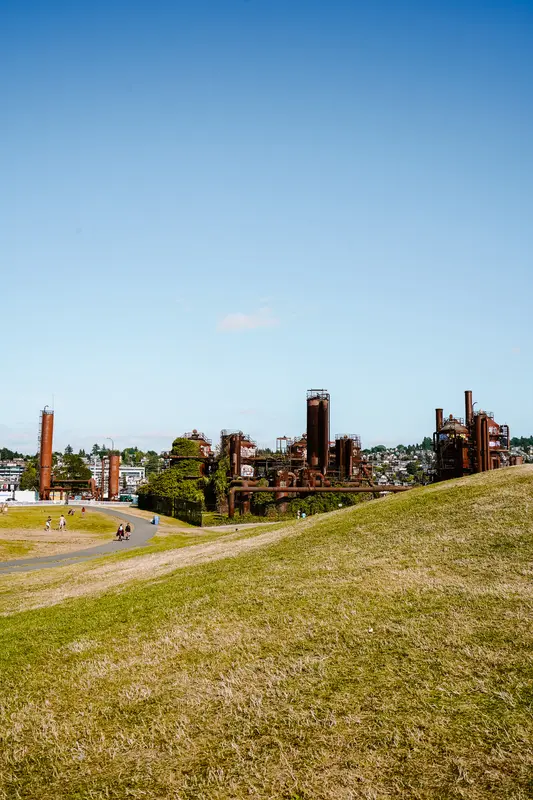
[0,506,116,561]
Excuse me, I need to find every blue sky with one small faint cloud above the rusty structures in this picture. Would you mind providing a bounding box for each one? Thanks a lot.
[0,0,533,452]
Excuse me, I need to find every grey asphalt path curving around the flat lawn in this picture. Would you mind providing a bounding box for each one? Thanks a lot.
[0,506,157,574]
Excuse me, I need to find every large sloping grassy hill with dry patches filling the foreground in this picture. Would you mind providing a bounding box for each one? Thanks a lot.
[0,467,533,800]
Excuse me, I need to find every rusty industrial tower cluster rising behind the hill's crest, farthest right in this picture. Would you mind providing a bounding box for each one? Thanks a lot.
[433,390,519,481]
